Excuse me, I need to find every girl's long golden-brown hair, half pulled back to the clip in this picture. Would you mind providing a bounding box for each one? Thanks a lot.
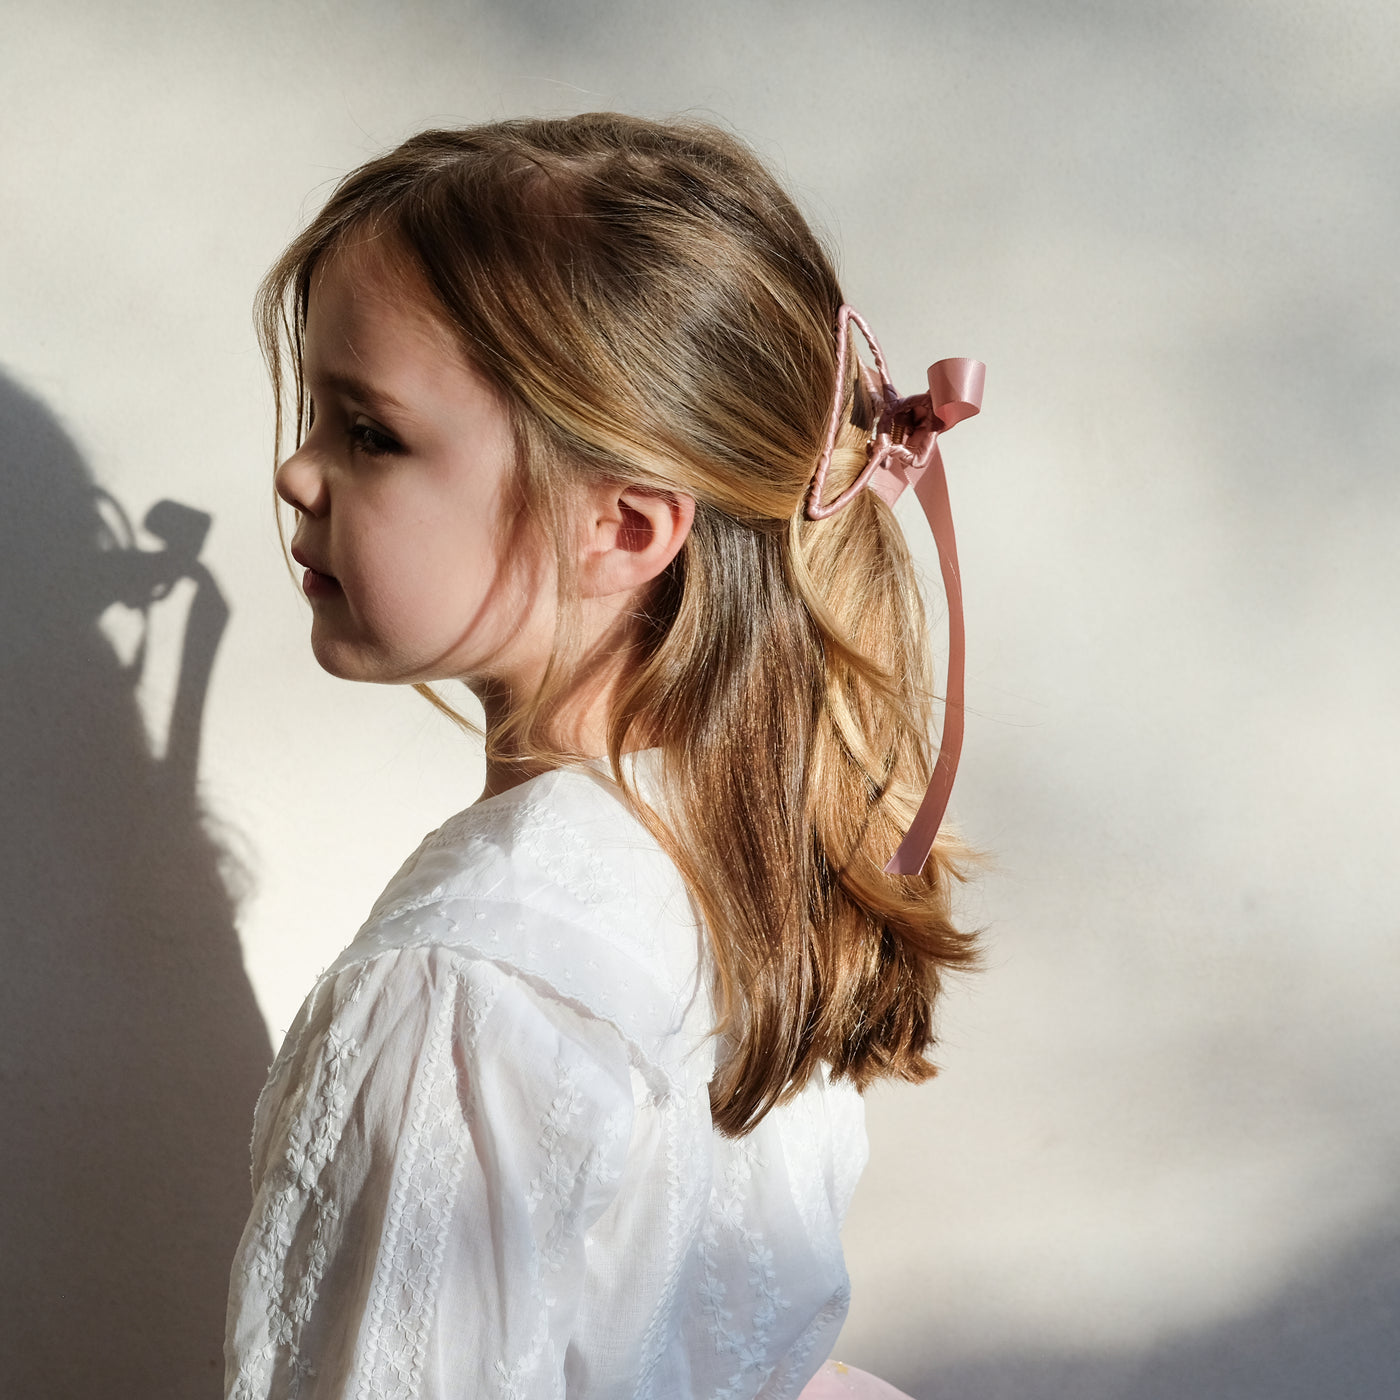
[259,113,974,1135]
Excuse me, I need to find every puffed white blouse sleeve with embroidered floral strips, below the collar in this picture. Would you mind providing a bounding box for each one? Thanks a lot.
[227,946,633,1400]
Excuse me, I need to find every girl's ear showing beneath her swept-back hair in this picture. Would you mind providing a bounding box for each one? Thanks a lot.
[578,482,696,598]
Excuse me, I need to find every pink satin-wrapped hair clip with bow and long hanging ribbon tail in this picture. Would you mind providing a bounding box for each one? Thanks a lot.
[806,305,987,875]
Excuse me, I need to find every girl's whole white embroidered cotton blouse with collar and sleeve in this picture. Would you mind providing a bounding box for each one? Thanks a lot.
[225,767,865,1400]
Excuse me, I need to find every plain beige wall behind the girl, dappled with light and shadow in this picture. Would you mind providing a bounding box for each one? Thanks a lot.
[0,0,1400,1400]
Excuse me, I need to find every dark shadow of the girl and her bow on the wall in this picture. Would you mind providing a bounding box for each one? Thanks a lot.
[0,375,270,1400]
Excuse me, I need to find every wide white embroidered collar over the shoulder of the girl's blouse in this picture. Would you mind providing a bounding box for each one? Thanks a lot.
[326,764,710,1089]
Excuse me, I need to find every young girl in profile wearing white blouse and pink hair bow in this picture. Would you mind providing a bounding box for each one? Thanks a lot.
[227,115,980,1400]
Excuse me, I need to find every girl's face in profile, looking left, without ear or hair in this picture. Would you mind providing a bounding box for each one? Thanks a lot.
[276,244,553,694]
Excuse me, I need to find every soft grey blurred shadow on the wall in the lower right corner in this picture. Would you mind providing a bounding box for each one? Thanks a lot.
[910,1214,1400,1400]
